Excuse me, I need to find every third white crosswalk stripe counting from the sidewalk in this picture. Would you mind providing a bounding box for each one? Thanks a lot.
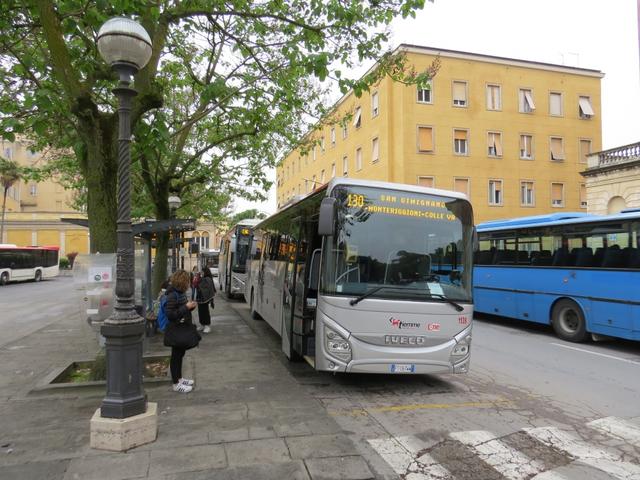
[524,427,640,480]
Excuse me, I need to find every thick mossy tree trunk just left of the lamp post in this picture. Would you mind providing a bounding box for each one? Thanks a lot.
[80,117,118,253]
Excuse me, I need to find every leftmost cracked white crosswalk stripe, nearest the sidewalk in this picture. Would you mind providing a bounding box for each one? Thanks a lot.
[367,436,452,480]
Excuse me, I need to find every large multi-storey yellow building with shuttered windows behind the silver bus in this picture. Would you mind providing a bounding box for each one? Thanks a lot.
[276,45,604,222]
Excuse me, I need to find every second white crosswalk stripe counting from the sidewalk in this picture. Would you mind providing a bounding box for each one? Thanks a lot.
[449,430,545,480]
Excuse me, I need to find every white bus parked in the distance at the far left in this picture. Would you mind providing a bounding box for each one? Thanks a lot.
[0,244,59,285]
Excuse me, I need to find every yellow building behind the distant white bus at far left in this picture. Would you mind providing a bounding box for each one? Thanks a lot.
[0,139,89,253]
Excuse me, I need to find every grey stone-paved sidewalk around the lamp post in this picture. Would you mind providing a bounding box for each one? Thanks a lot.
[0,296,374,480]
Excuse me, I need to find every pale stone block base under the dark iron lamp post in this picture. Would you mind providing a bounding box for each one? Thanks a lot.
[90,402,158,452]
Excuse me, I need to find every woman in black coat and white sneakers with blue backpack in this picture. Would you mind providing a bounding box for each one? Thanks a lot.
[164,270,200,393]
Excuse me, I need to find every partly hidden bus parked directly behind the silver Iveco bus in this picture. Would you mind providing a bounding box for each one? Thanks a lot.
[218,218,260,298]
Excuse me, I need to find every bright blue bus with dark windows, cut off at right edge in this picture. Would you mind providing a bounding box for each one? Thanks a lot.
[473,209,640,342]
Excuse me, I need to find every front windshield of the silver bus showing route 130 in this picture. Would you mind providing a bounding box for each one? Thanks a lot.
[321,186,473,302]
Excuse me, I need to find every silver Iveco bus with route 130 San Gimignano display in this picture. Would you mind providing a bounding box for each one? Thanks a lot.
[245,178,473,374]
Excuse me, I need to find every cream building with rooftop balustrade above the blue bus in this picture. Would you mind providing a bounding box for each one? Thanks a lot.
[582,142,640,214]
